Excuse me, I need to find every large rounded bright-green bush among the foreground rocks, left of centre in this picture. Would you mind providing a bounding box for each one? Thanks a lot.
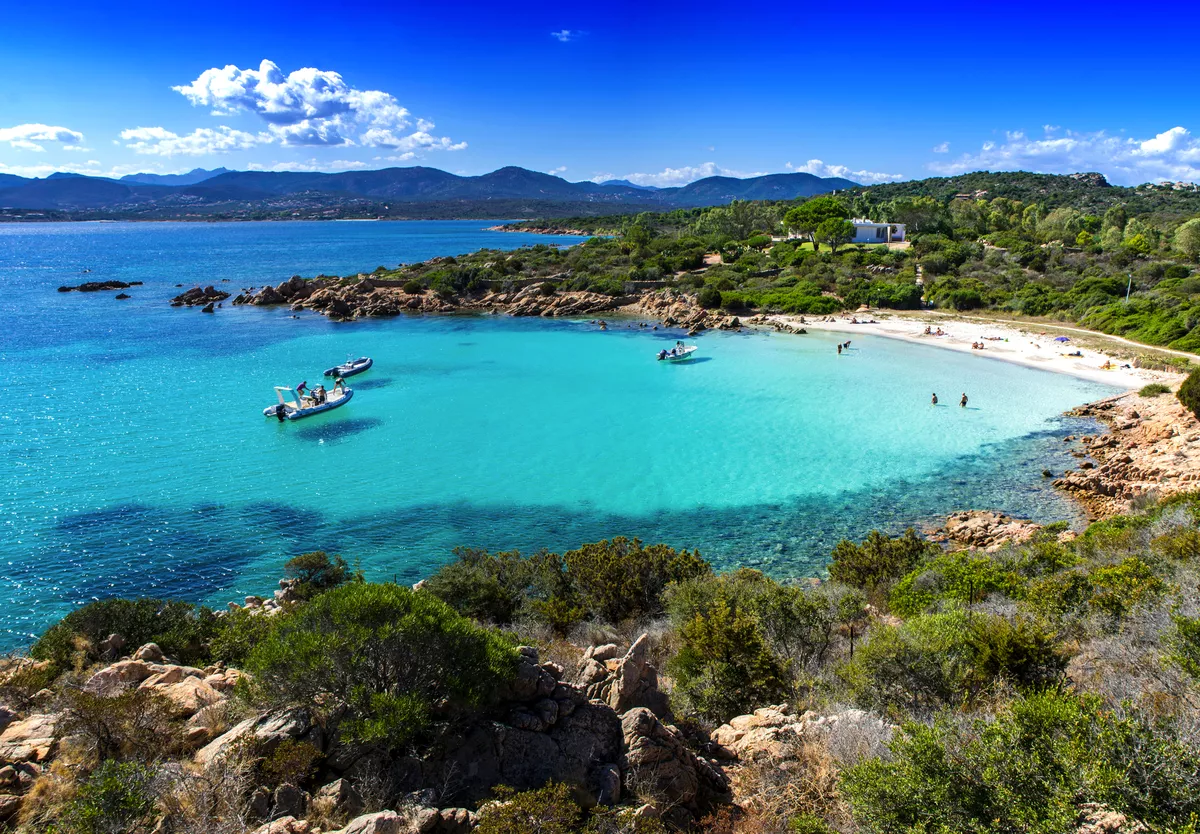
[246,583,516,745]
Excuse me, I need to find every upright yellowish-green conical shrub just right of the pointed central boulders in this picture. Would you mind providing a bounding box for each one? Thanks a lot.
[670,594,788,722]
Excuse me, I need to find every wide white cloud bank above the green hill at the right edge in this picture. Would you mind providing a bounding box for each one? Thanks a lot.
[929,125,1200,185]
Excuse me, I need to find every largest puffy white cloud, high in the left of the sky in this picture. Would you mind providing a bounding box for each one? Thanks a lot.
[172,60,467,150]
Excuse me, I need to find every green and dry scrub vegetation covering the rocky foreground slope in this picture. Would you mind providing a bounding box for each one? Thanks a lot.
[5,496,1200,834]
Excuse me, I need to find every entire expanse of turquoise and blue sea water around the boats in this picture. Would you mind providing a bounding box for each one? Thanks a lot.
[0,221,1112,644]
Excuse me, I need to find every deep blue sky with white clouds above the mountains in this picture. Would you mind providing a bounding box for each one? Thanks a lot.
[0,0,1200,185]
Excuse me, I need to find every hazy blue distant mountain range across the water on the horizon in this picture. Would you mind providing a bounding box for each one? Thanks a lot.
[0,167,859,220]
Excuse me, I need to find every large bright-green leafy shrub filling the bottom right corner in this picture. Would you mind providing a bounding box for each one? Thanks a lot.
[841,692,1200,834]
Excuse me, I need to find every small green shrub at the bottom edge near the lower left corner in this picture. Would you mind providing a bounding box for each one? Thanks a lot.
[64,761,157,834]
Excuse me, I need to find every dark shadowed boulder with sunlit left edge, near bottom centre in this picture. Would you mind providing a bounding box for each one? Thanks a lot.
[620,707,730,826]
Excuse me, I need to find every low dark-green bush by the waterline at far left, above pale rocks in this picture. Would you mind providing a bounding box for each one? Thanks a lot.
[29,599,217,670]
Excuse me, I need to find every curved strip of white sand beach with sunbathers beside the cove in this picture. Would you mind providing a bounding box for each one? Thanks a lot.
[767,310,1187,390]
